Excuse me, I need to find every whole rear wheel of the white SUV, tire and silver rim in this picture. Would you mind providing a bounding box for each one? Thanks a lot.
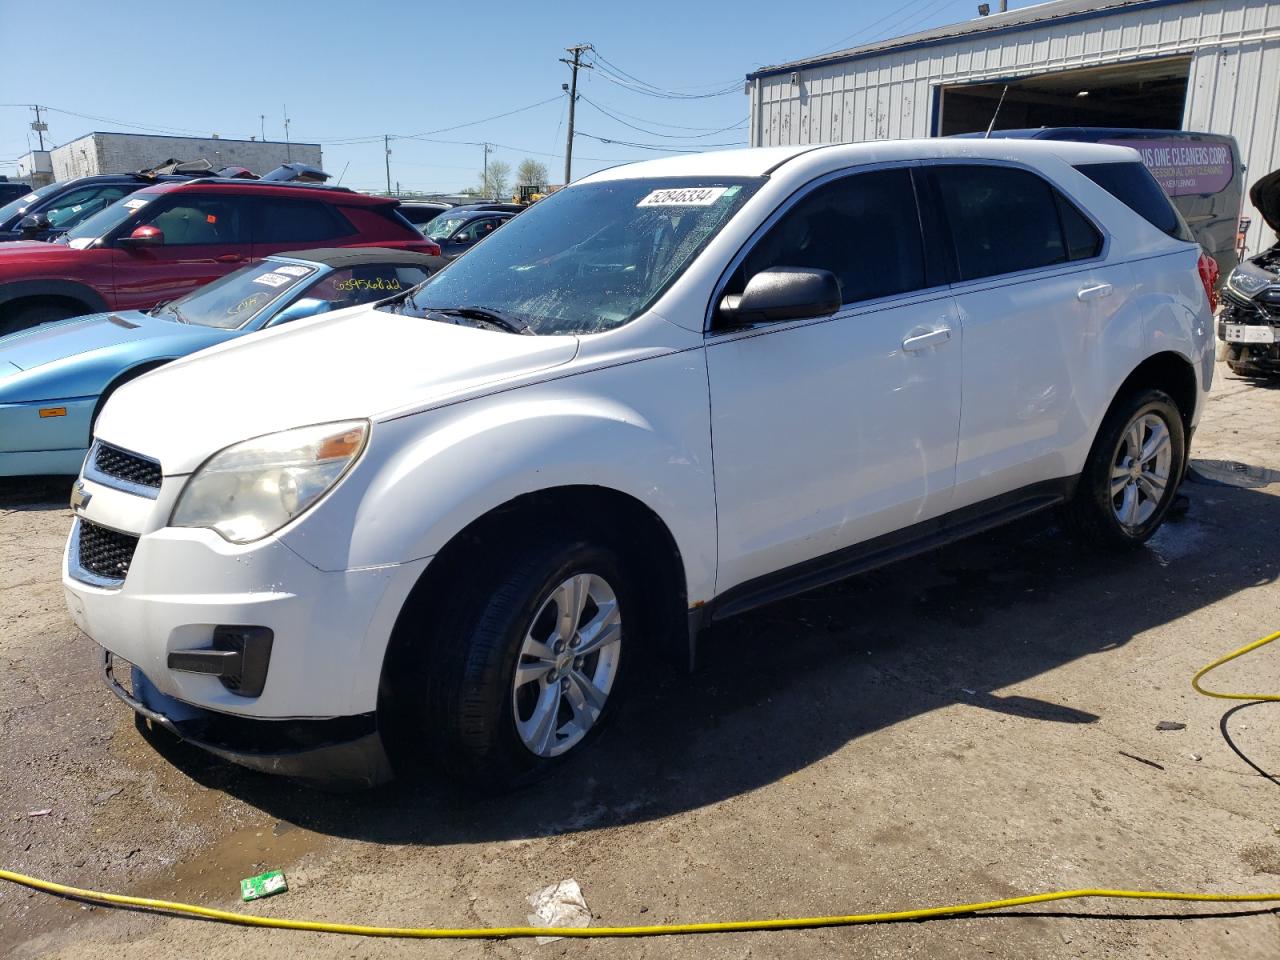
[1066,389,1187,549]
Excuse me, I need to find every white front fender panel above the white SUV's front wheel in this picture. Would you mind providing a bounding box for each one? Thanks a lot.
[282,348,716,604]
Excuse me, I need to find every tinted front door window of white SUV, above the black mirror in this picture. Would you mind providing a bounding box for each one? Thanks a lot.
[724,168,925,303]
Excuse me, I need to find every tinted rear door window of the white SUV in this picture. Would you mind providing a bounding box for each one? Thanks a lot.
[932,165,1102,280]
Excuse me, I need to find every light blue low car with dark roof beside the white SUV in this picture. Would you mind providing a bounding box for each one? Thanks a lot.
[0,247,433,476]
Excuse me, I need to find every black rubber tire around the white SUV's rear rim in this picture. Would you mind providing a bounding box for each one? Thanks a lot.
[1064,389,1187,552]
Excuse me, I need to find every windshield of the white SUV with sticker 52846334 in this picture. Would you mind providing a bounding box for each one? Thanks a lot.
[404,177,764,334]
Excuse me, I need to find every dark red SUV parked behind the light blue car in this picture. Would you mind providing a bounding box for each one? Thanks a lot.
[0,179,440,335]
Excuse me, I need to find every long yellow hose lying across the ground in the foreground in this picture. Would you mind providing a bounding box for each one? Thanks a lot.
[0,632,1280,940]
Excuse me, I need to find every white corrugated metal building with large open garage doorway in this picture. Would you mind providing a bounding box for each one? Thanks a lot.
[746,0,1280,251]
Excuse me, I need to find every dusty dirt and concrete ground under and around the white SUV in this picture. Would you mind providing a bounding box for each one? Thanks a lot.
[0,367,1280,960]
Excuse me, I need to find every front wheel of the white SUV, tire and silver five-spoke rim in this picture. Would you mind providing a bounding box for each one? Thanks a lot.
[397,541,632,788]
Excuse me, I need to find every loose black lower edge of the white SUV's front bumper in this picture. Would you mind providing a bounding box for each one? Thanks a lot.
[102,649,394,790]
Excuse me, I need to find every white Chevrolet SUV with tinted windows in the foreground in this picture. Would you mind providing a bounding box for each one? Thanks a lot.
[64,140,1213,785]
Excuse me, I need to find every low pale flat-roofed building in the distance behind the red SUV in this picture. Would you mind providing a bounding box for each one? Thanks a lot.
[50,132,321,180]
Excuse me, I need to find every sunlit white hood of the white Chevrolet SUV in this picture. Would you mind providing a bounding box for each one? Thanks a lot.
[95,307,577,475]
